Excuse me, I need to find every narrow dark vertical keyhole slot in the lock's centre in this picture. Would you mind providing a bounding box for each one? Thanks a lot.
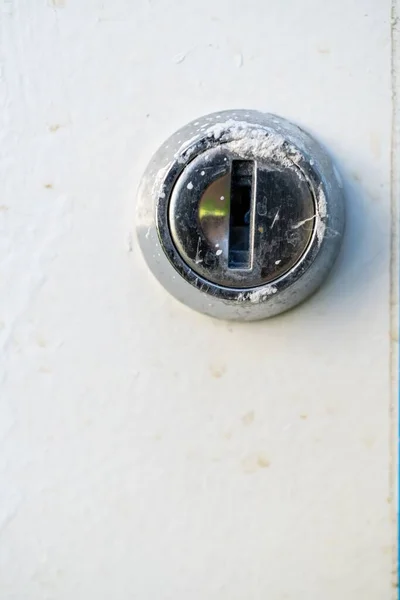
[228,160,254,269]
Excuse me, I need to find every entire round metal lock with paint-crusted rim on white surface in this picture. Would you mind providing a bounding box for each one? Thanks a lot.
[138,110,344,320]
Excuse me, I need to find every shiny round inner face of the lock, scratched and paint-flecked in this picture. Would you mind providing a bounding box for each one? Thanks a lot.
[169,145,316,288]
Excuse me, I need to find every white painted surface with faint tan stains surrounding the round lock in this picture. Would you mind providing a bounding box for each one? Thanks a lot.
[0,0,396,600]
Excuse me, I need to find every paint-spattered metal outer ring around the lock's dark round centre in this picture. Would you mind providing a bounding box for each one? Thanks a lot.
[137,110,344,320]
